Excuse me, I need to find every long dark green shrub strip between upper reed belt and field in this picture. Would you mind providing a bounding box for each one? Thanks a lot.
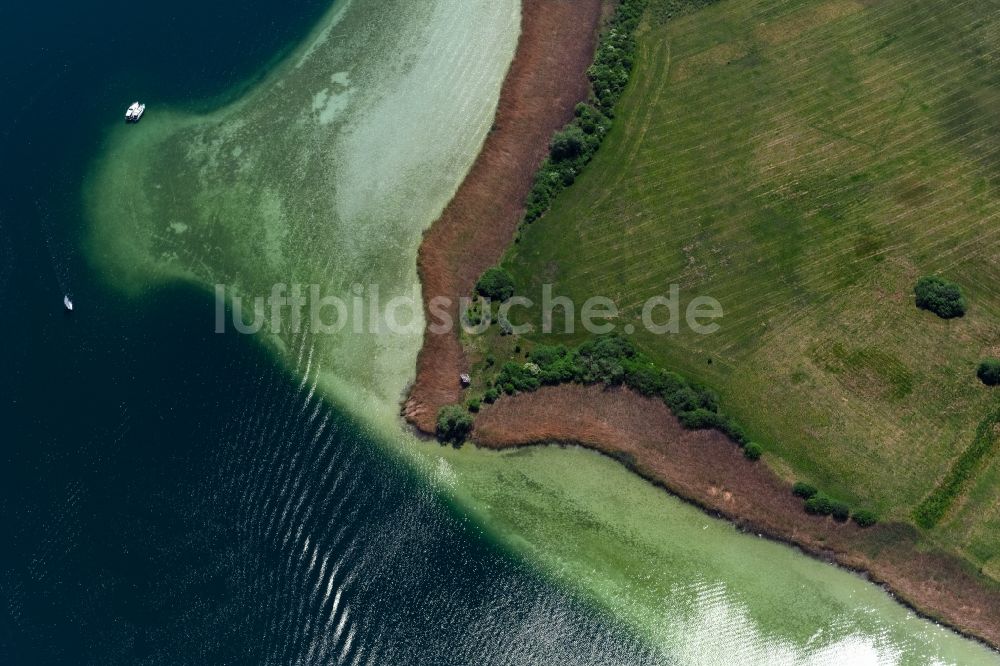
[523,0,646,224]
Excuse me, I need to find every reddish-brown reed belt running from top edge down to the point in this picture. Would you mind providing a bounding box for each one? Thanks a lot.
[403,0,602,433]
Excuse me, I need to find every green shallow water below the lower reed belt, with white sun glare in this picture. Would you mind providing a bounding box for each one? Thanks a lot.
[436,440,998,664]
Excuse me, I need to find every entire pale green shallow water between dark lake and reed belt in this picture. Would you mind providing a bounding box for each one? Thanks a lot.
[87,0,995,664]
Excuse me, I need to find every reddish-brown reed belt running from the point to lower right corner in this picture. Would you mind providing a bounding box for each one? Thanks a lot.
[475,385,1000,647]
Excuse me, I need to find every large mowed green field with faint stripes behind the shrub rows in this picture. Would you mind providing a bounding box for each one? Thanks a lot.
[505,0,1000,564]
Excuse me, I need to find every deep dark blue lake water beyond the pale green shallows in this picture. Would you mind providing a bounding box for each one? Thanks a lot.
[0,0,664,664]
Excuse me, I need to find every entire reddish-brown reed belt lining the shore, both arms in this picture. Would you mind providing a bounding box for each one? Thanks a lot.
[402,0,1000,650]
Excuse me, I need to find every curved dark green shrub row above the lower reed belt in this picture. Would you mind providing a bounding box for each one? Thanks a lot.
[485,335,763,460]
